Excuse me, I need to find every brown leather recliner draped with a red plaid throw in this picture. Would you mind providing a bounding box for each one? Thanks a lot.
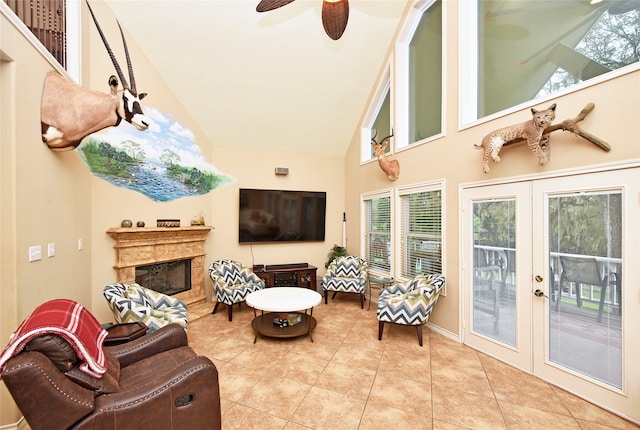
[2,324,221,430]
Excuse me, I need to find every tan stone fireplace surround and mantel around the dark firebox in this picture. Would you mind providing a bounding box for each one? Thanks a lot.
[107,226,213,304]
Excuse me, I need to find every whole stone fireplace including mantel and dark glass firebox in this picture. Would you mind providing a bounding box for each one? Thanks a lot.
[107,226,212,304]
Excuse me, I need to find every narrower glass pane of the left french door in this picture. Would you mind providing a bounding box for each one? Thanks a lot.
[472,199,517,347]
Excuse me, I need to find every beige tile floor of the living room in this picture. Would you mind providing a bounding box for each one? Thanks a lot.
[188,294,640,430]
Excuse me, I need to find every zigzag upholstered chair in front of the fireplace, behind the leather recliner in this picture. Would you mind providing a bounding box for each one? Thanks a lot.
[102,283,188,333]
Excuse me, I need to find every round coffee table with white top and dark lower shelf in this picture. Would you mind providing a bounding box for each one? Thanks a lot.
[246,287,322,343]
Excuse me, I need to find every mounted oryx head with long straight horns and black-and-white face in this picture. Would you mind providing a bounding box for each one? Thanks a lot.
[40,0,149,151]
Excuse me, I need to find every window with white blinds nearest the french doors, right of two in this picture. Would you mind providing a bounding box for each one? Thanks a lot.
[398,182,444,278]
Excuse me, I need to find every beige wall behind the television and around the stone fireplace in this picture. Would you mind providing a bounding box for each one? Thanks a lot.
[84,3,344,321]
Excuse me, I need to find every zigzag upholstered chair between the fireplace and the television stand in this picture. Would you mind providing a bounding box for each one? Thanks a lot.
[209,260,264,321]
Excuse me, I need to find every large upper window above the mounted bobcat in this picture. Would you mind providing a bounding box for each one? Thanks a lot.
[459,0,640,124]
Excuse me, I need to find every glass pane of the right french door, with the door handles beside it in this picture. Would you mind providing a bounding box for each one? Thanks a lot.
[548,191,622,388]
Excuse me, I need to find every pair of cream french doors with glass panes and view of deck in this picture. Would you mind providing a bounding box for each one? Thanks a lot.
[461,168,640,421]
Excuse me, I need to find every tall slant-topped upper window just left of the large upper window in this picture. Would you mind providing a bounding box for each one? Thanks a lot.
[396,1,443,147]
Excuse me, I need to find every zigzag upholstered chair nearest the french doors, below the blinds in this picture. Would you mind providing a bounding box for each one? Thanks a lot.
[377,274,445,346]
